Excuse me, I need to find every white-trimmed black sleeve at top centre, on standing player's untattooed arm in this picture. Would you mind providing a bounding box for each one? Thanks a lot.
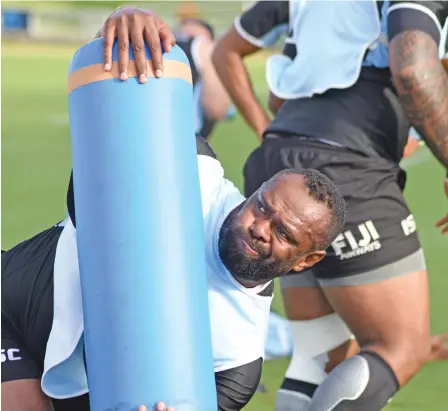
[234,1,289,48]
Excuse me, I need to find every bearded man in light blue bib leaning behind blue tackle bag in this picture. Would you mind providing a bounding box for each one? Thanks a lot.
[1,12,345,411]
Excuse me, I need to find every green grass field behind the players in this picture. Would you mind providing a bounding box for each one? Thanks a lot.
[1,44,448,411]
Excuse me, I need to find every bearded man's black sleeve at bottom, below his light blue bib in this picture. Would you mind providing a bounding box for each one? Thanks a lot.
[215,358,263,411]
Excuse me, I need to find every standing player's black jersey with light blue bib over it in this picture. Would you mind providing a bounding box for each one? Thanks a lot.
[234,0,448,162]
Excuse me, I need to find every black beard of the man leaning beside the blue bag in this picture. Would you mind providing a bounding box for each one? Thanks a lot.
[218,207,291,282]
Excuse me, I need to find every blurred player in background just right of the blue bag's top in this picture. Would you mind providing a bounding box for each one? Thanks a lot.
[174,16,235,139]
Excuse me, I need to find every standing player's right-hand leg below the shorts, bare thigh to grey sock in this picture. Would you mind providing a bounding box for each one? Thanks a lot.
[310,270,430,411]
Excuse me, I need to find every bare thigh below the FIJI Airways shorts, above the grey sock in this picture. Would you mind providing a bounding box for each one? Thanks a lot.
[325,270,430,385]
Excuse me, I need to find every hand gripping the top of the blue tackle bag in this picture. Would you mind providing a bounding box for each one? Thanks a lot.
[100,7,176,83]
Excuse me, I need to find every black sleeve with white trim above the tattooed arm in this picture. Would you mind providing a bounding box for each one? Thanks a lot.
[387,0,448,45]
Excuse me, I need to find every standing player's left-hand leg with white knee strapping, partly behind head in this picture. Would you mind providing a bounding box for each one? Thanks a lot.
[244,139,358,411]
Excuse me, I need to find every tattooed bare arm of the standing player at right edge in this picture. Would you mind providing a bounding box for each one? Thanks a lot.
[389,30,448,169]
